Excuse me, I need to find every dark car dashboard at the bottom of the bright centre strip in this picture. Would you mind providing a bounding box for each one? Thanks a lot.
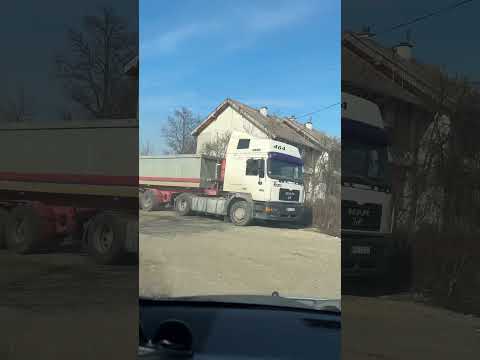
[138,297,341,360]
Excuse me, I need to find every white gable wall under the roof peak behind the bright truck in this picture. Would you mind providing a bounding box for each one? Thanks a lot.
[197,106,268,154]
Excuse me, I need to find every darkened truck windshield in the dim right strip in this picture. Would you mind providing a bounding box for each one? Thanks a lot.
[342,143,389,184]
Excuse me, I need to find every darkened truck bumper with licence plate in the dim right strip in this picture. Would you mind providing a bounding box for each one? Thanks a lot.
[342,233,394,278]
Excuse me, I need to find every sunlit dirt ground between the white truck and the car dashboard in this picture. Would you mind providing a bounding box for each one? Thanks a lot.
[139,211,341,299]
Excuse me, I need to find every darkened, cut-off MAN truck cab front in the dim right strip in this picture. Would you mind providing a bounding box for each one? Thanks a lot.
[341,93,395,277]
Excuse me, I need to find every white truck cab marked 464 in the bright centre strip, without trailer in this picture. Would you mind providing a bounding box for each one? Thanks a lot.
[223,132,305,221]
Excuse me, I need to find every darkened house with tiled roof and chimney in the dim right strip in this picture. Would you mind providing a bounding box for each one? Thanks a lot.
[342,32,480,229]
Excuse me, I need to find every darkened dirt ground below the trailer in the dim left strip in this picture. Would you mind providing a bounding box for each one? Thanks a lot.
[0,250,138,360]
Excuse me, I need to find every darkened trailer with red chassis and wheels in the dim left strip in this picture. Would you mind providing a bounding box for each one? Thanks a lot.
[0,120,138,264]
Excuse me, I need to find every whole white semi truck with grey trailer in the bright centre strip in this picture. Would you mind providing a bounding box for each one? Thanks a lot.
[139,132,305,226]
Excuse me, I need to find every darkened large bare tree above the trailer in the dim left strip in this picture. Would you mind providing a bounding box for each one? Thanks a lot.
[55,9,138,118]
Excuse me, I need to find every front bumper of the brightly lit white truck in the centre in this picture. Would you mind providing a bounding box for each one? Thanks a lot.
[254,201,303,222]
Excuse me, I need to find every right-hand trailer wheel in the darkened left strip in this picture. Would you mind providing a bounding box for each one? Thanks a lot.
[88,214,126,265]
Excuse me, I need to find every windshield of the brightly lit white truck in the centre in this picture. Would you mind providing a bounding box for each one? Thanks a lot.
[267,153,303,183]
